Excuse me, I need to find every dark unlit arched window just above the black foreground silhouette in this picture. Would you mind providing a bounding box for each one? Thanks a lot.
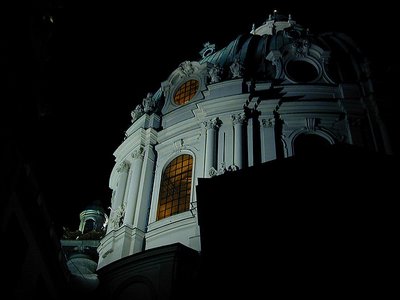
[294,133,330,156]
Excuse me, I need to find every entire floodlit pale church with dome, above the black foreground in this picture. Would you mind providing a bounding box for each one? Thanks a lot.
[98,15,390,268]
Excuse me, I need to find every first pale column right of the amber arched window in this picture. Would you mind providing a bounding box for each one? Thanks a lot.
[203,118,222,177]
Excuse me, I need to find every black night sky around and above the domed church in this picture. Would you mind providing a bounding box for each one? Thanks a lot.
[1,1,399,228]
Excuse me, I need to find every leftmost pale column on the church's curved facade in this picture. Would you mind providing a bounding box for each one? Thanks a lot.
[107,162,129,233]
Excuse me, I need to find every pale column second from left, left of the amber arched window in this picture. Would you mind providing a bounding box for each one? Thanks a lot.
[124,147,144,226]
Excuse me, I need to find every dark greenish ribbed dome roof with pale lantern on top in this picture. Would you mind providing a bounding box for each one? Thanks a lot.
[200,15,364,84]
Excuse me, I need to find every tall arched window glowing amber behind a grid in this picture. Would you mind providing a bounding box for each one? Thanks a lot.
[157,154,193,220]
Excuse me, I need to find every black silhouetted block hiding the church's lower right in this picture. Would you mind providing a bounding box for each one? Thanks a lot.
[197,145,398,297]
